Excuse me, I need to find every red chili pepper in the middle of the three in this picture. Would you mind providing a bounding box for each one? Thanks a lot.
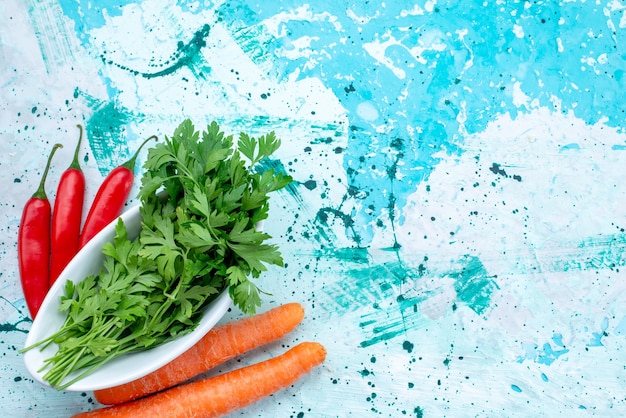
[50,125,85,286]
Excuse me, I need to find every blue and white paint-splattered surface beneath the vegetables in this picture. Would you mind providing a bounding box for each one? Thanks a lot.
[0,0,626,417]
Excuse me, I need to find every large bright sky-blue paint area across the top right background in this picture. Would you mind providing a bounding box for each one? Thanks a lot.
[218,0,626,246]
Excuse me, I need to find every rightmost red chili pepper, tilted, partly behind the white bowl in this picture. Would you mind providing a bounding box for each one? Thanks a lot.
[78,135,157,248]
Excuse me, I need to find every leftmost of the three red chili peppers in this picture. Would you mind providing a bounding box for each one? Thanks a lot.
[17,144,62,319]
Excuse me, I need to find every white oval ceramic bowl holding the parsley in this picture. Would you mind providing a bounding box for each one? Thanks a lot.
[24,205,232,392]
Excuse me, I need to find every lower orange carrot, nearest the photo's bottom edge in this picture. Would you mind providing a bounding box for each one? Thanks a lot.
[74,342,326,418]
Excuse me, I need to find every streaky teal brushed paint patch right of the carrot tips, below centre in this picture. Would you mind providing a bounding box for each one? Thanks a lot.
[318,249,498,347]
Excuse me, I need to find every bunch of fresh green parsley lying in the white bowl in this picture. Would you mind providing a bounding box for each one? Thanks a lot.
[24,120,291,390]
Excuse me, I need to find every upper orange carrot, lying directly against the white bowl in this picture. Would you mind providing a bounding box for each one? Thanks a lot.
[94,302,304,405]
